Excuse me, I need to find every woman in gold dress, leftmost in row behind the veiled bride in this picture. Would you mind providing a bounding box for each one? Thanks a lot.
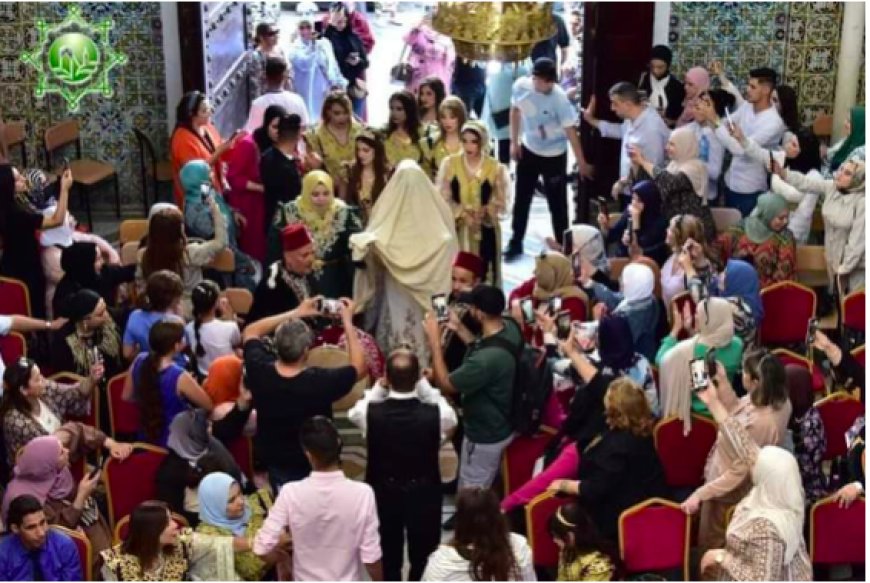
[303,91,363,198]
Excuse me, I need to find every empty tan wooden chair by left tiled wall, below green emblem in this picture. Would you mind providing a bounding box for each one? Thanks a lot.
[45,119,121,229]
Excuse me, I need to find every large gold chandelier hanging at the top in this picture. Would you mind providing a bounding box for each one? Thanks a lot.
[432,2,556,62]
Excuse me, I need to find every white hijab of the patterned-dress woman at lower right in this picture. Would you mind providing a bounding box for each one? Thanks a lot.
[728,445,804,565]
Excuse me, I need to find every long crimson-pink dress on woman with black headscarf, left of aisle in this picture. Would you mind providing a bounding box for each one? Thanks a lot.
[227,134,267,263]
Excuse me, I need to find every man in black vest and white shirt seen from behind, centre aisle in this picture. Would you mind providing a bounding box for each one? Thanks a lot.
[348,348,456,581]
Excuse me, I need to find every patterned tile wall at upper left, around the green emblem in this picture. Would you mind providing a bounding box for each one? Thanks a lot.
[0,2,169,213]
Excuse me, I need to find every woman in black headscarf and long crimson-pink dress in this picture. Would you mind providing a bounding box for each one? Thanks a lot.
[227,105,287,263]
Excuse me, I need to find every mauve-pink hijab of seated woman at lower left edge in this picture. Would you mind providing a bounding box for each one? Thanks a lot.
[3,435,75,521]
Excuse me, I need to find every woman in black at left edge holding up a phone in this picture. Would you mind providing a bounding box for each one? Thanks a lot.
[0,164,73,318]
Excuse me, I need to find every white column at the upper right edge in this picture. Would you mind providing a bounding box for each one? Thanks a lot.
[831,2,864,143]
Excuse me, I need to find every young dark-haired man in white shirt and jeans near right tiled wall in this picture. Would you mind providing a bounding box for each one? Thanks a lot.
[713,67,785,217]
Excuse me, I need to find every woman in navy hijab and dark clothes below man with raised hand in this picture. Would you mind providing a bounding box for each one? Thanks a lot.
[598,180,668,265]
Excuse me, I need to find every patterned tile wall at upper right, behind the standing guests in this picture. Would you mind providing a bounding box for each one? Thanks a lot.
[669,2,864,124]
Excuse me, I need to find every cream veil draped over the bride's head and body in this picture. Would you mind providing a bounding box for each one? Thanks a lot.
[350,160,459,310]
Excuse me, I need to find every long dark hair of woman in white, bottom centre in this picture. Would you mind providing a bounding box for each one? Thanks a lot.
[452,488,519,581]
